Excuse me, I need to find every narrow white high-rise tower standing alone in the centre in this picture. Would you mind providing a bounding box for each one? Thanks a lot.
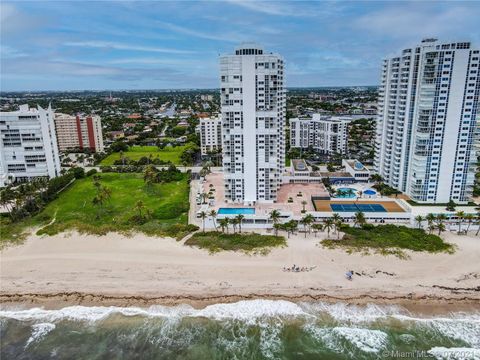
[220,43,286,204]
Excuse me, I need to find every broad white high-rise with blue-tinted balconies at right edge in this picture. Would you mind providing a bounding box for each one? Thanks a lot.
[375,39,480,203]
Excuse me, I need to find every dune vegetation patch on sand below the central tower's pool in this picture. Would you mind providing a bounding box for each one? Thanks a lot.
[185,231,287,254]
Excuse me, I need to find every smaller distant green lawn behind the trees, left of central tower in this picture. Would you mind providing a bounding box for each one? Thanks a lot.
[100,146,185,166]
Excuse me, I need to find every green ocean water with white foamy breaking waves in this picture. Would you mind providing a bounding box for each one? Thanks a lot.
[0,300,480,360]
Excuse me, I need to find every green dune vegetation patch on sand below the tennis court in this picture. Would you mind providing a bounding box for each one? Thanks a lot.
[321,225,454,258]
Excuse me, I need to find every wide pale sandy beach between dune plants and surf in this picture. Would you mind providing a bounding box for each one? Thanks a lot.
[0,232,480,305]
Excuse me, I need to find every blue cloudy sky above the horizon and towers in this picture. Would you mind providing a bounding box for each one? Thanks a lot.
[0,0,480,91]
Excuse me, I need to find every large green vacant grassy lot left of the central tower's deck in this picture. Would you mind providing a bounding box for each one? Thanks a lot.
[1,173,195,248]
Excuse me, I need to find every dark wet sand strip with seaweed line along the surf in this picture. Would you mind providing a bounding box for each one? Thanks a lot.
[0,292,480,313]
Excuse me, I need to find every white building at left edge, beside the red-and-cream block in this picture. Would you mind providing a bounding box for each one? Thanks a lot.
[0,105,60,186]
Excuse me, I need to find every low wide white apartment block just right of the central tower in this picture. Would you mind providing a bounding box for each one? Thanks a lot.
[290,114,352,155]
